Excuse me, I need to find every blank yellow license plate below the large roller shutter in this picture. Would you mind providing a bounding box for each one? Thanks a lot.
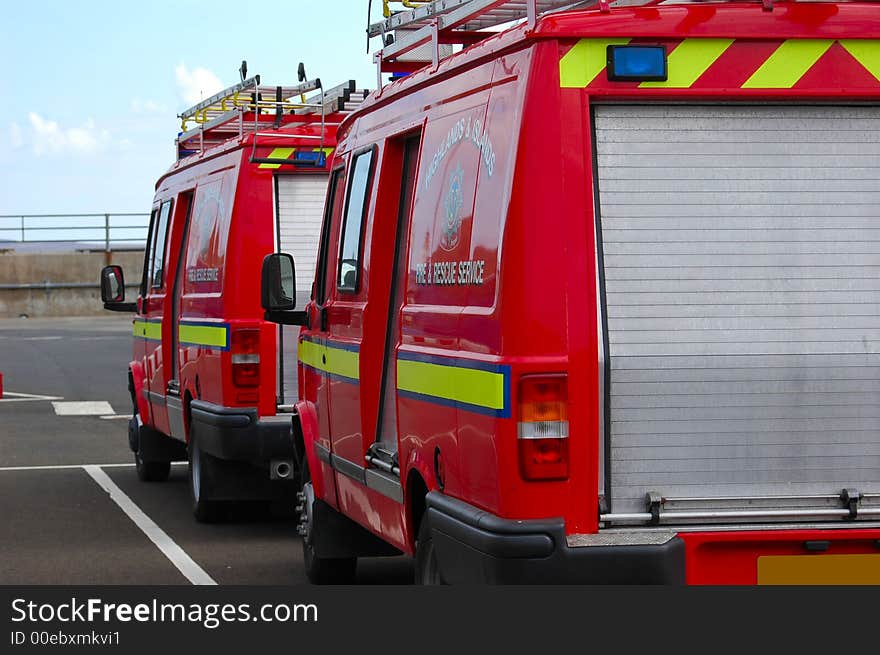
[758,555,880,585]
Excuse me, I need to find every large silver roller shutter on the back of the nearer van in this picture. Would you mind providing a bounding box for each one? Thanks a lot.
[594,105,880,513]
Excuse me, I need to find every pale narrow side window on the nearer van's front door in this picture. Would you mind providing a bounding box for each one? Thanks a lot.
[336,149,374,293]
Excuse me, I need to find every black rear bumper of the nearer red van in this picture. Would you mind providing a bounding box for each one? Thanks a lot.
[427,491,685,584]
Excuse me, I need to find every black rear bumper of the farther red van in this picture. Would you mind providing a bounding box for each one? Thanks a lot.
[190,400,294,464]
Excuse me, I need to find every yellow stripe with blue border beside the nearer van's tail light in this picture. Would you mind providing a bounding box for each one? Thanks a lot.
[397,352,510,418]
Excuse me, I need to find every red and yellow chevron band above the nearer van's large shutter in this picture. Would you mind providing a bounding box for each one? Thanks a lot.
[559,38,880,91]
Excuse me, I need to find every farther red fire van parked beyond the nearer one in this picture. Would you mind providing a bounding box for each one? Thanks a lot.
[102,67,364,521]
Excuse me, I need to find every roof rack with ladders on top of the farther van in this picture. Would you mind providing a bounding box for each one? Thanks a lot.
[175,61,369,161]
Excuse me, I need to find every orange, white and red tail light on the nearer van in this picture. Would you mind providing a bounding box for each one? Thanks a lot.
[517,375,568,480]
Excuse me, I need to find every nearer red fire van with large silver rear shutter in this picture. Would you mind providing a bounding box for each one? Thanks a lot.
[263,0,880,584]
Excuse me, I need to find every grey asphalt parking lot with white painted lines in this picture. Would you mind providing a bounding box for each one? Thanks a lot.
[0,315,413,585]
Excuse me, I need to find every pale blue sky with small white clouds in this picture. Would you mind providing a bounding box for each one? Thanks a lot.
[0,0,381,223]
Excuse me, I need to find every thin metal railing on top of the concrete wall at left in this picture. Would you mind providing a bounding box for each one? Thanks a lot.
[0,212,150,252]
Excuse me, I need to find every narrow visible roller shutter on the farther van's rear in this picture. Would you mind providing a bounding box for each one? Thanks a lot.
[275,173,327,403]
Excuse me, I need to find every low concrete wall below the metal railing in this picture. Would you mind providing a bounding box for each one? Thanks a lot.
[0,251,144,318]
